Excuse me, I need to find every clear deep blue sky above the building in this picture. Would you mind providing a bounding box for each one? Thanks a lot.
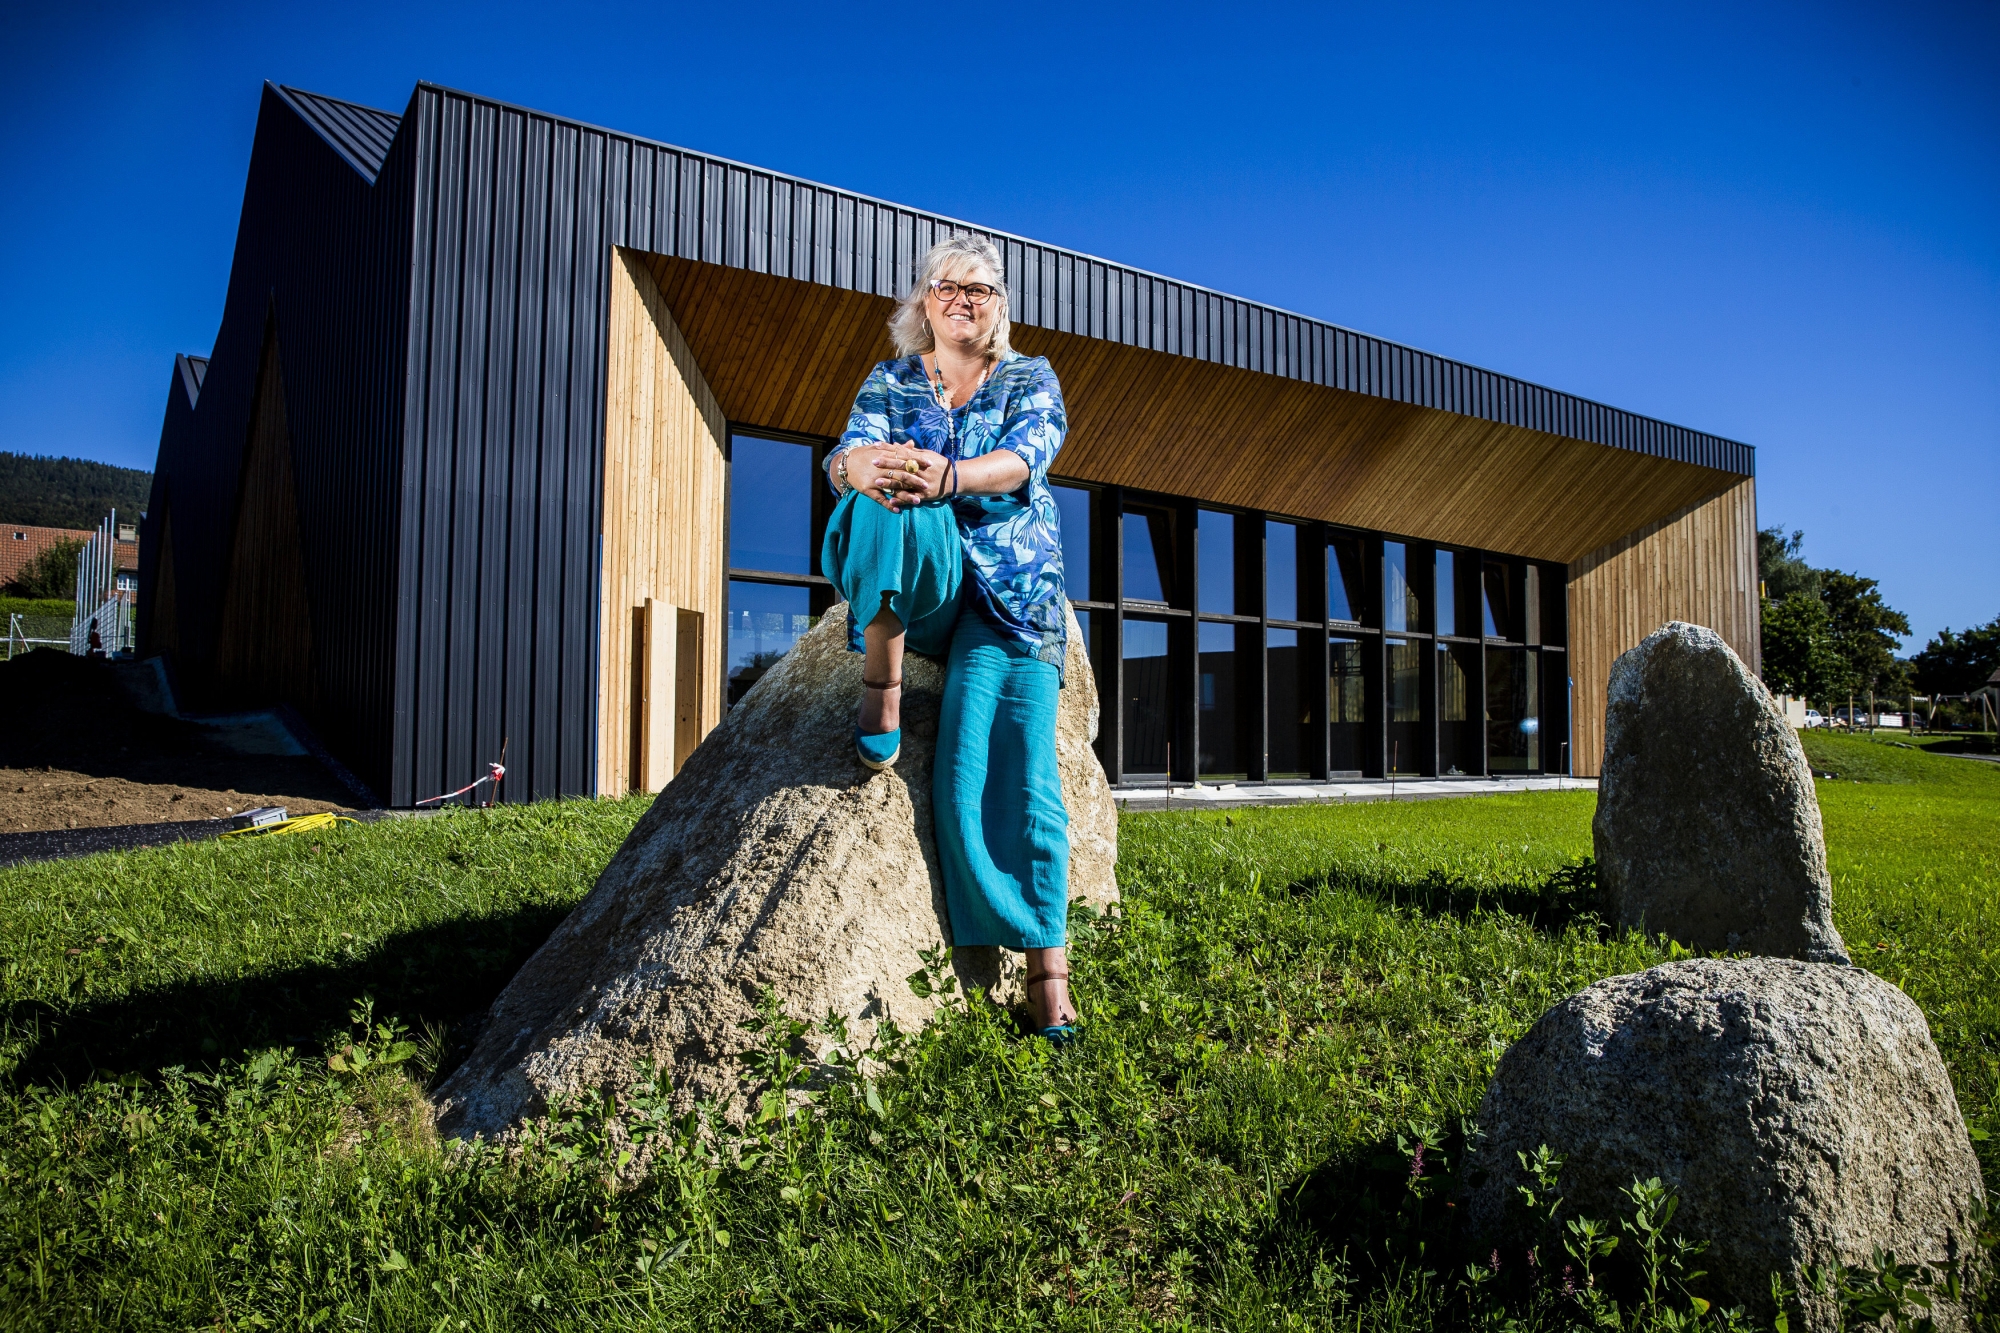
[0,4,2000,642]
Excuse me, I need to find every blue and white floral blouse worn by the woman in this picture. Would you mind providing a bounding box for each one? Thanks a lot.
[826,352,1068,671]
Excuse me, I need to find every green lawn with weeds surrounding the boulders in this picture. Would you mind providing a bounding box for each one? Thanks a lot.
[0,737,2000,1329]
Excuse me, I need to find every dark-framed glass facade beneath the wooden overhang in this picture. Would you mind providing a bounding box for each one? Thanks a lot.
[724,422,1570,783]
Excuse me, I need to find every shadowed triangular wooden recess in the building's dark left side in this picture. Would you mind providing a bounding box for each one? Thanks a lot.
[210,330,318,719]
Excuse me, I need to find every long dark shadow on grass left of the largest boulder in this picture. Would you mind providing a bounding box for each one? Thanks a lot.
[0,907,570,1085]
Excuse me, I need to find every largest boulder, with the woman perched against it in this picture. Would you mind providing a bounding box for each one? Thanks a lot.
[438,604,1118,1135]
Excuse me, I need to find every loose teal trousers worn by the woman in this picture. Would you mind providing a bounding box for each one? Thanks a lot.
[820,492,1070,949]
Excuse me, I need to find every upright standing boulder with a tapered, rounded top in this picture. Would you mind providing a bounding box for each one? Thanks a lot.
[1590,620,1848,963]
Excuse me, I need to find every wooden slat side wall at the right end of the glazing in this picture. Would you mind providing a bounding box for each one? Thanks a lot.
[1570,478,1762,775]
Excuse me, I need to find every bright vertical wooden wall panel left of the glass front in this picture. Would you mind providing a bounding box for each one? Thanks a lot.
[598,250,728,797]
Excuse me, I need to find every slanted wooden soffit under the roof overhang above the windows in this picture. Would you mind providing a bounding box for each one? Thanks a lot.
[646,256,1742,564]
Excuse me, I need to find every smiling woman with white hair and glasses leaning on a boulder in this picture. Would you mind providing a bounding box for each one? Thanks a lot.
[820,236,1076,1043]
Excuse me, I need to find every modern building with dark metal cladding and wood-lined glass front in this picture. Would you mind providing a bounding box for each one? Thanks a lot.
[140,84,1758,805]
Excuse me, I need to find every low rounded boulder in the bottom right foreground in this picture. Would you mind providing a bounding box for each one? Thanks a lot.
[1466,959,1984,1327]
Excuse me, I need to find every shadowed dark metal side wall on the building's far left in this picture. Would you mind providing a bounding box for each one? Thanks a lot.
[140,84,412,791]
